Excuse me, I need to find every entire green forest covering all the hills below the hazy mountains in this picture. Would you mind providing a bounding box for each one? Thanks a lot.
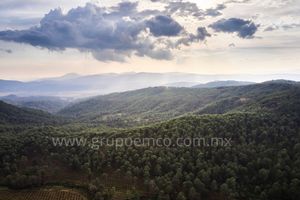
[0,81,300,200]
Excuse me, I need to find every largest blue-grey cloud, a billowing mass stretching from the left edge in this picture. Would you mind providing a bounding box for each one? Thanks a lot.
[0,2,205,62]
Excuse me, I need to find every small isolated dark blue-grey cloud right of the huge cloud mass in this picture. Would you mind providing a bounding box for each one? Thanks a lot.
[209,18,259,38]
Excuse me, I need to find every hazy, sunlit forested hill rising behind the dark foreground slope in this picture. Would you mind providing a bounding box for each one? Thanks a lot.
[59,81,300,126]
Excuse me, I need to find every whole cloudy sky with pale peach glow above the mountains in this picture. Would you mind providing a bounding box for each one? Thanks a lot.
[0,0,300,80]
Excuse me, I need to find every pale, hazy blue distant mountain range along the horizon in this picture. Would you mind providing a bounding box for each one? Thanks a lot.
[0,72,300,97]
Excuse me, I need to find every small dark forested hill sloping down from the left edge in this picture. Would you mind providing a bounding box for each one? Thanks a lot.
[0,101,61,125]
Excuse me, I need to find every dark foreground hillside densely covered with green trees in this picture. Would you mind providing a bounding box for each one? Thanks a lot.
[0,113,300,200]
